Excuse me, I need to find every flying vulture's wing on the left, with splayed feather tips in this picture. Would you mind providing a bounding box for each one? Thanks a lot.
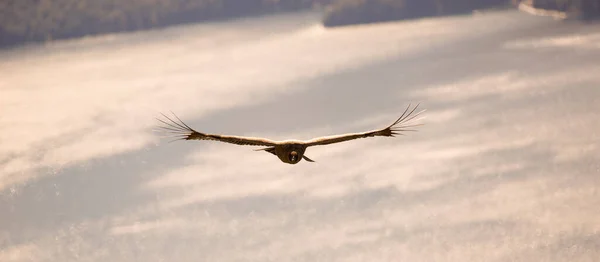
[157,111,277,146]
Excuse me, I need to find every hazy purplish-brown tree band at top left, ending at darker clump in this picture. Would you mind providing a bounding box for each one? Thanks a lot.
[0,0,329,46]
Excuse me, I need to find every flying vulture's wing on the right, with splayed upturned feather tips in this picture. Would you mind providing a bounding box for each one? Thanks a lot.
[304,104,425,146]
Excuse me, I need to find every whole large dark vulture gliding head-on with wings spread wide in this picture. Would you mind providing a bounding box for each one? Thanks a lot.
[157,104,425,164]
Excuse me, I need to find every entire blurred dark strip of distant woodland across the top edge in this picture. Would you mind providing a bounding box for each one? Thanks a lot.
[0,0,600,47]
